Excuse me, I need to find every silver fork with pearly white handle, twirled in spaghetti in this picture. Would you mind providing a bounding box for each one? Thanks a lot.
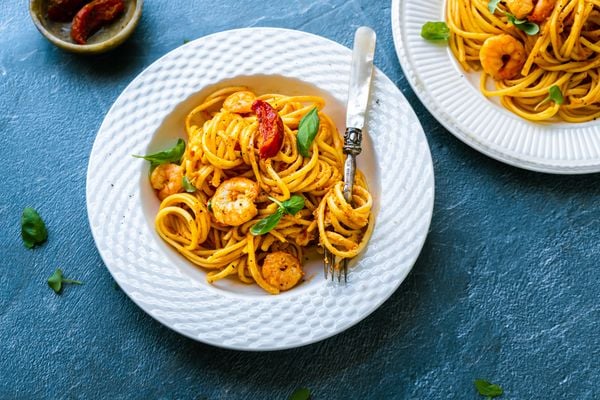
[323,26,375,283]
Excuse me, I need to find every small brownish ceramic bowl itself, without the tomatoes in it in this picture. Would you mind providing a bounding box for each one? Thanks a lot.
[29,0,144,54]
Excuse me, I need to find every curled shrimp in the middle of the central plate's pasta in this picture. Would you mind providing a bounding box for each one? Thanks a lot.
[210,177,259,226]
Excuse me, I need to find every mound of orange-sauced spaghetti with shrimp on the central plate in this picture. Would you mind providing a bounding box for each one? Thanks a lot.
[151,87,373,294]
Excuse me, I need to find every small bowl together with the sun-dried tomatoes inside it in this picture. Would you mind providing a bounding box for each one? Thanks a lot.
[29,0,144,54]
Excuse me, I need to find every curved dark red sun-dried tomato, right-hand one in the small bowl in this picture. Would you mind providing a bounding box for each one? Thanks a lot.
[71,0,125,44]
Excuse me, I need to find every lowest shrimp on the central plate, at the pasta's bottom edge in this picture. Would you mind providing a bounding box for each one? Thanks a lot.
[262,251,304,291]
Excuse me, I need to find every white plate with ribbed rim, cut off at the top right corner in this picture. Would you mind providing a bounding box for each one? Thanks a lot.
[392,0,600,174]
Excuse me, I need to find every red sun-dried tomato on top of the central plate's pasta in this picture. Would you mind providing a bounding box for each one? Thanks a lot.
[252,100,283,159]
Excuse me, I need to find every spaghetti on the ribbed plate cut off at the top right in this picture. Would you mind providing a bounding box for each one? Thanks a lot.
[446,0,600,122]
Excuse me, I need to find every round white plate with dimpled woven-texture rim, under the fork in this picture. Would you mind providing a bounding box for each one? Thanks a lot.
[87,28,434,350]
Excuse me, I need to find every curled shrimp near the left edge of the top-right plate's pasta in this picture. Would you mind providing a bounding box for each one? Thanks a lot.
[479,34,527,81]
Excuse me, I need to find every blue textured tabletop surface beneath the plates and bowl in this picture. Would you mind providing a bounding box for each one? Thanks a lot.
[0,0,600,400]
